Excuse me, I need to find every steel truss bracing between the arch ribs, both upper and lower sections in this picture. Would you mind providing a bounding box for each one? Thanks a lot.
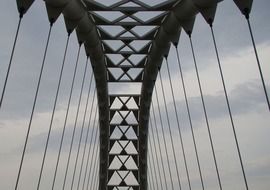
[84,0,176,190]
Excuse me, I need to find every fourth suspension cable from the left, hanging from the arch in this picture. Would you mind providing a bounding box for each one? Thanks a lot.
[52,43,81,190]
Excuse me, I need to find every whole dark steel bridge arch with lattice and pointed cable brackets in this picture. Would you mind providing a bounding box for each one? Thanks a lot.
[17,0,252,190]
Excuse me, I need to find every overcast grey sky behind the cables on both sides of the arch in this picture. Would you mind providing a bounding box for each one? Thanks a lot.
[0,0,270,190]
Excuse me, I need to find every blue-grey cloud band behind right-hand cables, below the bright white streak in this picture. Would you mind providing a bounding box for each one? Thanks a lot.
[152,80,270,134]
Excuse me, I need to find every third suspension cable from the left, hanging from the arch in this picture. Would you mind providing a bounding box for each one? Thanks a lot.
[37,33,70,190]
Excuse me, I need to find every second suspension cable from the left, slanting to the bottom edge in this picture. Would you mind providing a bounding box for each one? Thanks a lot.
[15,22,53,190]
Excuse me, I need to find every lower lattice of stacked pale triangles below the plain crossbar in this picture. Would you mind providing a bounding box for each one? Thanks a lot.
[108,95,139,190]
